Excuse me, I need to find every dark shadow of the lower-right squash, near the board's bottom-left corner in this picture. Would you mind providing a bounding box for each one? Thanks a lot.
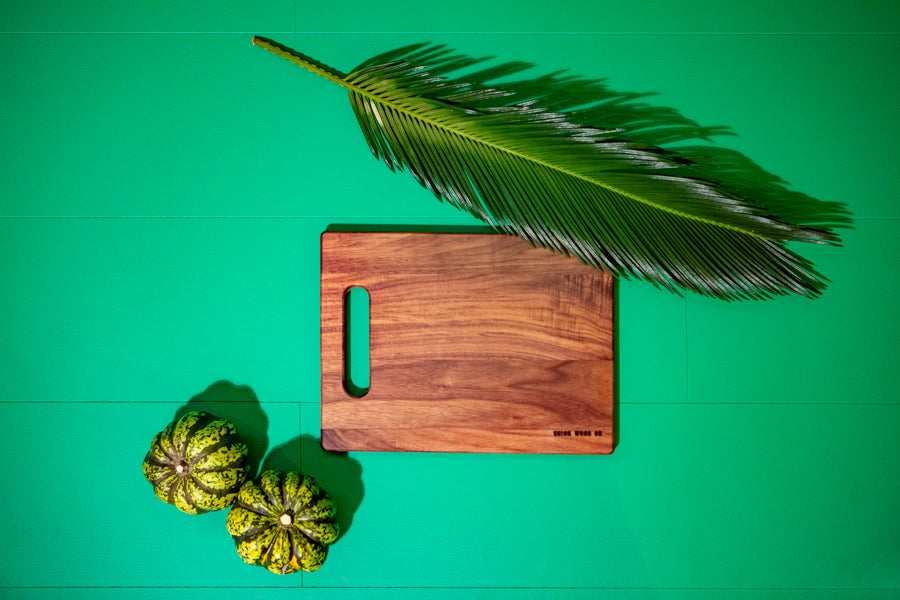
[260,435,364,539]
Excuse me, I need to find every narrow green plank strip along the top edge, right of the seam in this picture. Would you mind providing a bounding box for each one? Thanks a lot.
[297,0,898,33]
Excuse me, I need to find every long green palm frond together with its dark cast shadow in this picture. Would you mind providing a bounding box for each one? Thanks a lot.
[254,38,849,300]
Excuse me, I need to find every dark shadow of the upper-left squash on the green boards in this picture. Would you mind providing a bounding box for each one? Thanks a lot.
[175,381,269,479]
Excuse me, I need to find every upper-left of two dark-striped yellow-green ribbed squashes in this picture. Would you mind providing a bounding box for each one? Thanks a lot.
[144,411,249,515]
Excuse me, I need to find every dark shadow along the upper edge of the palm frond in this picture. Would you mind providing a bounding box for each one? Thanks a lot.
[434,52,853,228]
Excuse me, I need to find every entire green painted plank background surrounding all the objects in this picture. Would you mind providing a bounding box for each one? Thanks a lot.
[0,0,900,600]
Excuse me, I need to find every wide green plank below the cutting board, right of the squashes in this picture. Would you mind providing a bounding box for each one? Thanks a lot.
[301,404,900,589]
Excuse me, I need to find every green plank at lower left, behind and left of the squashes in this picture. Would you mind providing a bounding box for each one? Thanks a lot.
[0,398,300,584]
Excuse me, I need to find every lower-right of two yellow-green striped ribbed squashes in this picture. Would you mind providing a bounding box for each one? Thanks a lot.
[226,470,339,575]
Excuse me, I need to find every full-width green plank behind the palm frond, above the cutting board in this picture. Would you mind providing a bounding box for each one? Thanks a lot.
[0,34,900,220]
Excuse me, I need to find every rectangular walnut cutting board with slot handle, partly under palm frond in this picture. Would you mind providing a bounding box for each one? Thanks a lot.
[321,232,614,454]
